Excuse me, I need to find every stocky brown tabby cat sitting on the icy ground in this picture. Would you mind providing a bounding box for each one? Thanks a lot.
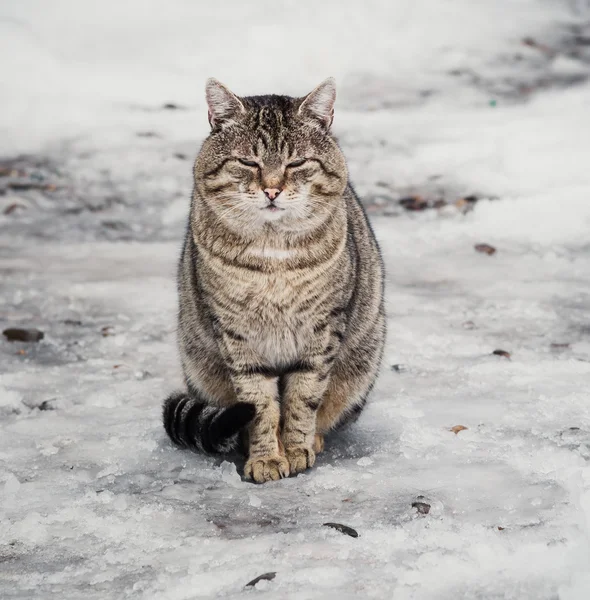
[163,78,385,483]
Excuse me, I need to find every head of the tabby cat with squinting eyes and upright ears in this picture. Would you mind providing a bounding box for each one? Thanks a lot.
[194,79,348,233]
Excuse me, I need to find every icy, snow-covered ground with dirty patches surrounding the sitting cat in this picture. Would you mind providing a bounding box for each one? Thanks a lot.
[0,0,590,600]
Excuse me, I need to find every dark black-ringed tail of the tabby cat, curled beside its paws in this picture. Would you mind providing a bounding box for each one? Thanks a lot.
[162,392,255,454]
